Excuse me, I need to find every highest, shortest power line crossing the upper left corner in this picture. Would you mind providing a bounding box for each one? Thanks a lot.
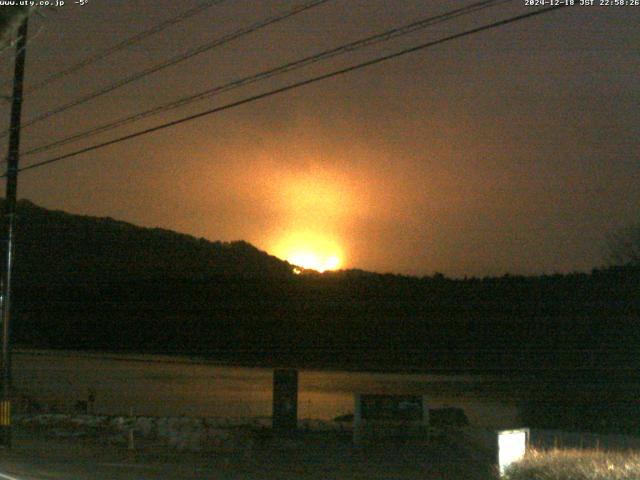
[1,0,226,93]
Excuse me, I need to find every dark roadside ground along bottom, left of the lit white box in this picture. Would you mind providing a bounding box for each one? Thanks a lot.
[0,431,495,480]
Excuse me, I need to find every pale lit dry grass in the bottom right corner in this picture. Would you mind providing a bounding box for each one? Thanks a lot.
[503,450,640,480]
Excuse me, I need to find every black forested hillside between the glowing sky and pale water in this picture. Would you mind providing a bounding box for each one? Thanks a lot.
[2,202,640,373]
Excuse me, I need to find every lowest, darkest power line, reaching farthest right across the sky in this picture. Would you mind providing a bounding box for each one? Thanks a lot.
[8,5,568,178]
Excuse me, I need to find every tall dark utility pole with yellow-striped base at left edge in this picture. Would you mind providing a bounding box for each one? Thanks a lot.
[0,17,28,448]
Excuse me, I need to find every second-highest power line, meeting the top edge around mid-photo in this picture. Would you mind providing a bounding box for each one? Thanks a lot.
[0,0,330,142]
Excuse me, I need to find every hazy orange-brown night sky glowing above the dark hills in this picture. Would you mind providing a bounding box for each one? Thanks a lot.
[0,0,640,277]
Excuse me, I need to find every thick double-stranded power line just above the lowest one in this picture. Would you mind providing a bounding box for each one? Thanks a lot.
[22,0,513,160]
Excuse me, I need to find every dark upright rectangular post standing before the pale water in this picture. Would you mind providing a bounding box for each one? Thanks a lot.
[273,368,298,433]
